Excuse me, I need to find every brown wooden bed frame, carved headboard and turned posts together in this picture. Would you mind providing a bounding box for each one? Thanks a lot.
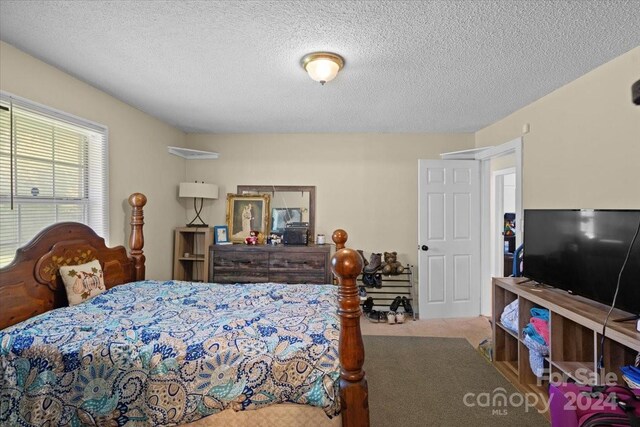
[0,193,369,427]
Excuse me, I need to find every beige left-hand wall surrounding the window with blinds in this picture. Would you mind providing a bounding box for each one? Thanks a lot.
[0,42,186,279]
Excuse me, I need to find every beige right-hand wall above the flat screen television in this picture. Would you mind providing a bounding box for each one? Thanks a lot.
[476,47,640,209]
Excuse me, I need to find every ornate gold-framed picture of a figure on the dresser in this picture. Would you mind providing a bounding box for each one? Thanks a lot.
[227,194,271,243]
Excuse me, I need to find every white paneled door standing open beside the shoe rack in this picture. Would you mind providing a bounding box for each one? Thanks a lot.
[418,160,480,319]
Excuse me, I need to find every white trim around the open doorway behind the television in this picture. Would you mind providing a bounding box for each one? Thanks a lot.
[440,136,524,316]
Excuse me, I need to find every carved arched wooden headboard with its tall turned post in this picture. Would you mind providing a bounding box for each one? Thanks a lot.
[0,193,147,329]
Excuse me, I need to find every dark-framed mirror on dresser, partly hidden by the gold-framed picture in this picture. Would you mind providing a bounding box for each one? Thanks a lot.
[237,185,316,242]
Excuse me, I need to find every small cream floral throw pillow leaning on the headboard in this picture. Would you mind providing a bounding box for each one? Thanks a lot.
[60,260,106,305]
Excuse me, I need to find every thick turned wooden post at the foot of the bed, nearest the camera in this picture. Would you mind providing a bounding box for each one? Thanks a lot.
[331,230,369,427]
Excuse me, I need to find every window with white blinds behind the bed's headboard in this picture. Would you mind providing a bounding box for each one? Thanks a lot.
[0,93,109,266]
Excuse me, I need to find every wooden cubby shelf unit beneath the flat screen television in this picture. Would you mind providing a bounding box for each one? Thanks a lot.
[492,277,640,412]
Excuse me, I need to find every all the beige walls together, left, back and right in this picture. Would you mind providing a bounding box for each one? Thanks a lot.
[5,36,640,290]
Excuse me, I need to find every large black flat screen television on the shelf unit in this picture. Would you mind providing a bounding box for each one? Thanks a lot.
[523,209,640,315]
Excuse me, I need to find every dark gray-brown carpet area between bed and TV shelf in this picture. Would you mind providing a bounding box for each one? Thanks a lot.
[364,336,549,427]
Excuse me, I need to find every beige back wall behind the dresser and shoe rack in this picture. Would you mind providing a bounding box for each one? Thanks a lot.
[187,134,474,265]
